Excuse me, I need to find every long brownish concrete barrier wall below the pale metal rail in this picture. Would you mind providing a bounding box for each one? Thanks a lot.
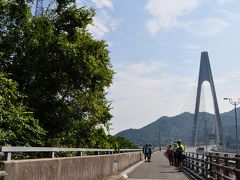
[4,152,143,180]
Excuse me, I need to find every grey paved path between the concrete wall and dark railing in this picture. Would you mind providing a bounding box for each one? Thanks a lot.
[127,151,188,180]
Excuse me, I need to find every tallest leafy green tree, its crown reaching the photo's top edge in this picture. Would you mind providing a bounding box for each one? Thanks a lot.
[0,0,113,147]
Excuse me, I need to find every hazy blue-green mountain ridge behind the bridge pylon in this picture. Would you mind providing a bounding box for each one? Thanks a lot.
[116,108,240,146]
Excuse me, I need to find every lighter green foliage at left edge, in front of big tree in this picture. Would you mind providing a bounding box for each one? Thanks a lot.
[0,73,45,146]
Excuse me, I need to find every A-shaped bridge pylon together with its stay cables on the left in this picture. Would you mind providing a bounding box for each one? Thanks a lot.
[171,52,224,147]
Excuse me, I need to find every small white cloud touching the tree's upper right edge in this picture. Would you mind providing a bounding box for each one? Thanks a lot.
[88,11,117,39]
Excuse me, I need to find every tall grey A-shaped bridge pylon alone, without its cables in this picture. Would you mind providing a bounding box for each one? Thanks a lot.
[191,52,223,146]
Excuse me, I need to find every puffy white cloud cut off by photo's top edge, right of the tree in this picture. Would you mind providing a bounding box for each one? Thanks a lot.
[145,0,199,34]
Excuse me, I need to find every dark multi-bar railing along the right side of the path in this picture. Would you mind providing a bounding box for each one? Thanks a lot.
[183,153,240,180]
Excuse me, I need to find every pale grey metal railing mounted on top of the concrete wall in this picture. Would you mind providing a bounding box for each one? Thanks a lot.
[0,146,142,161]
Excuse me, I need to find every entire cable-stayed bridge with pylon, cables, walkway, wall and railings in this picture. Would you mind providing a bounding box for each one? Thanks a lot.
[0,52,240,180]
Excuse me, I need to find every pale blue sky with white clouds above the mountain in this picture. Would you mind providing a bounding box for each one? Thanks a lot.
[77,0,240,135]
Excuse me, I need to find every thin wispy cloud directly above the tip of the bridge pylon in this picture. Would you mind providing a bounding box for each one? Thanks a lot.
[184,18,229,37]
